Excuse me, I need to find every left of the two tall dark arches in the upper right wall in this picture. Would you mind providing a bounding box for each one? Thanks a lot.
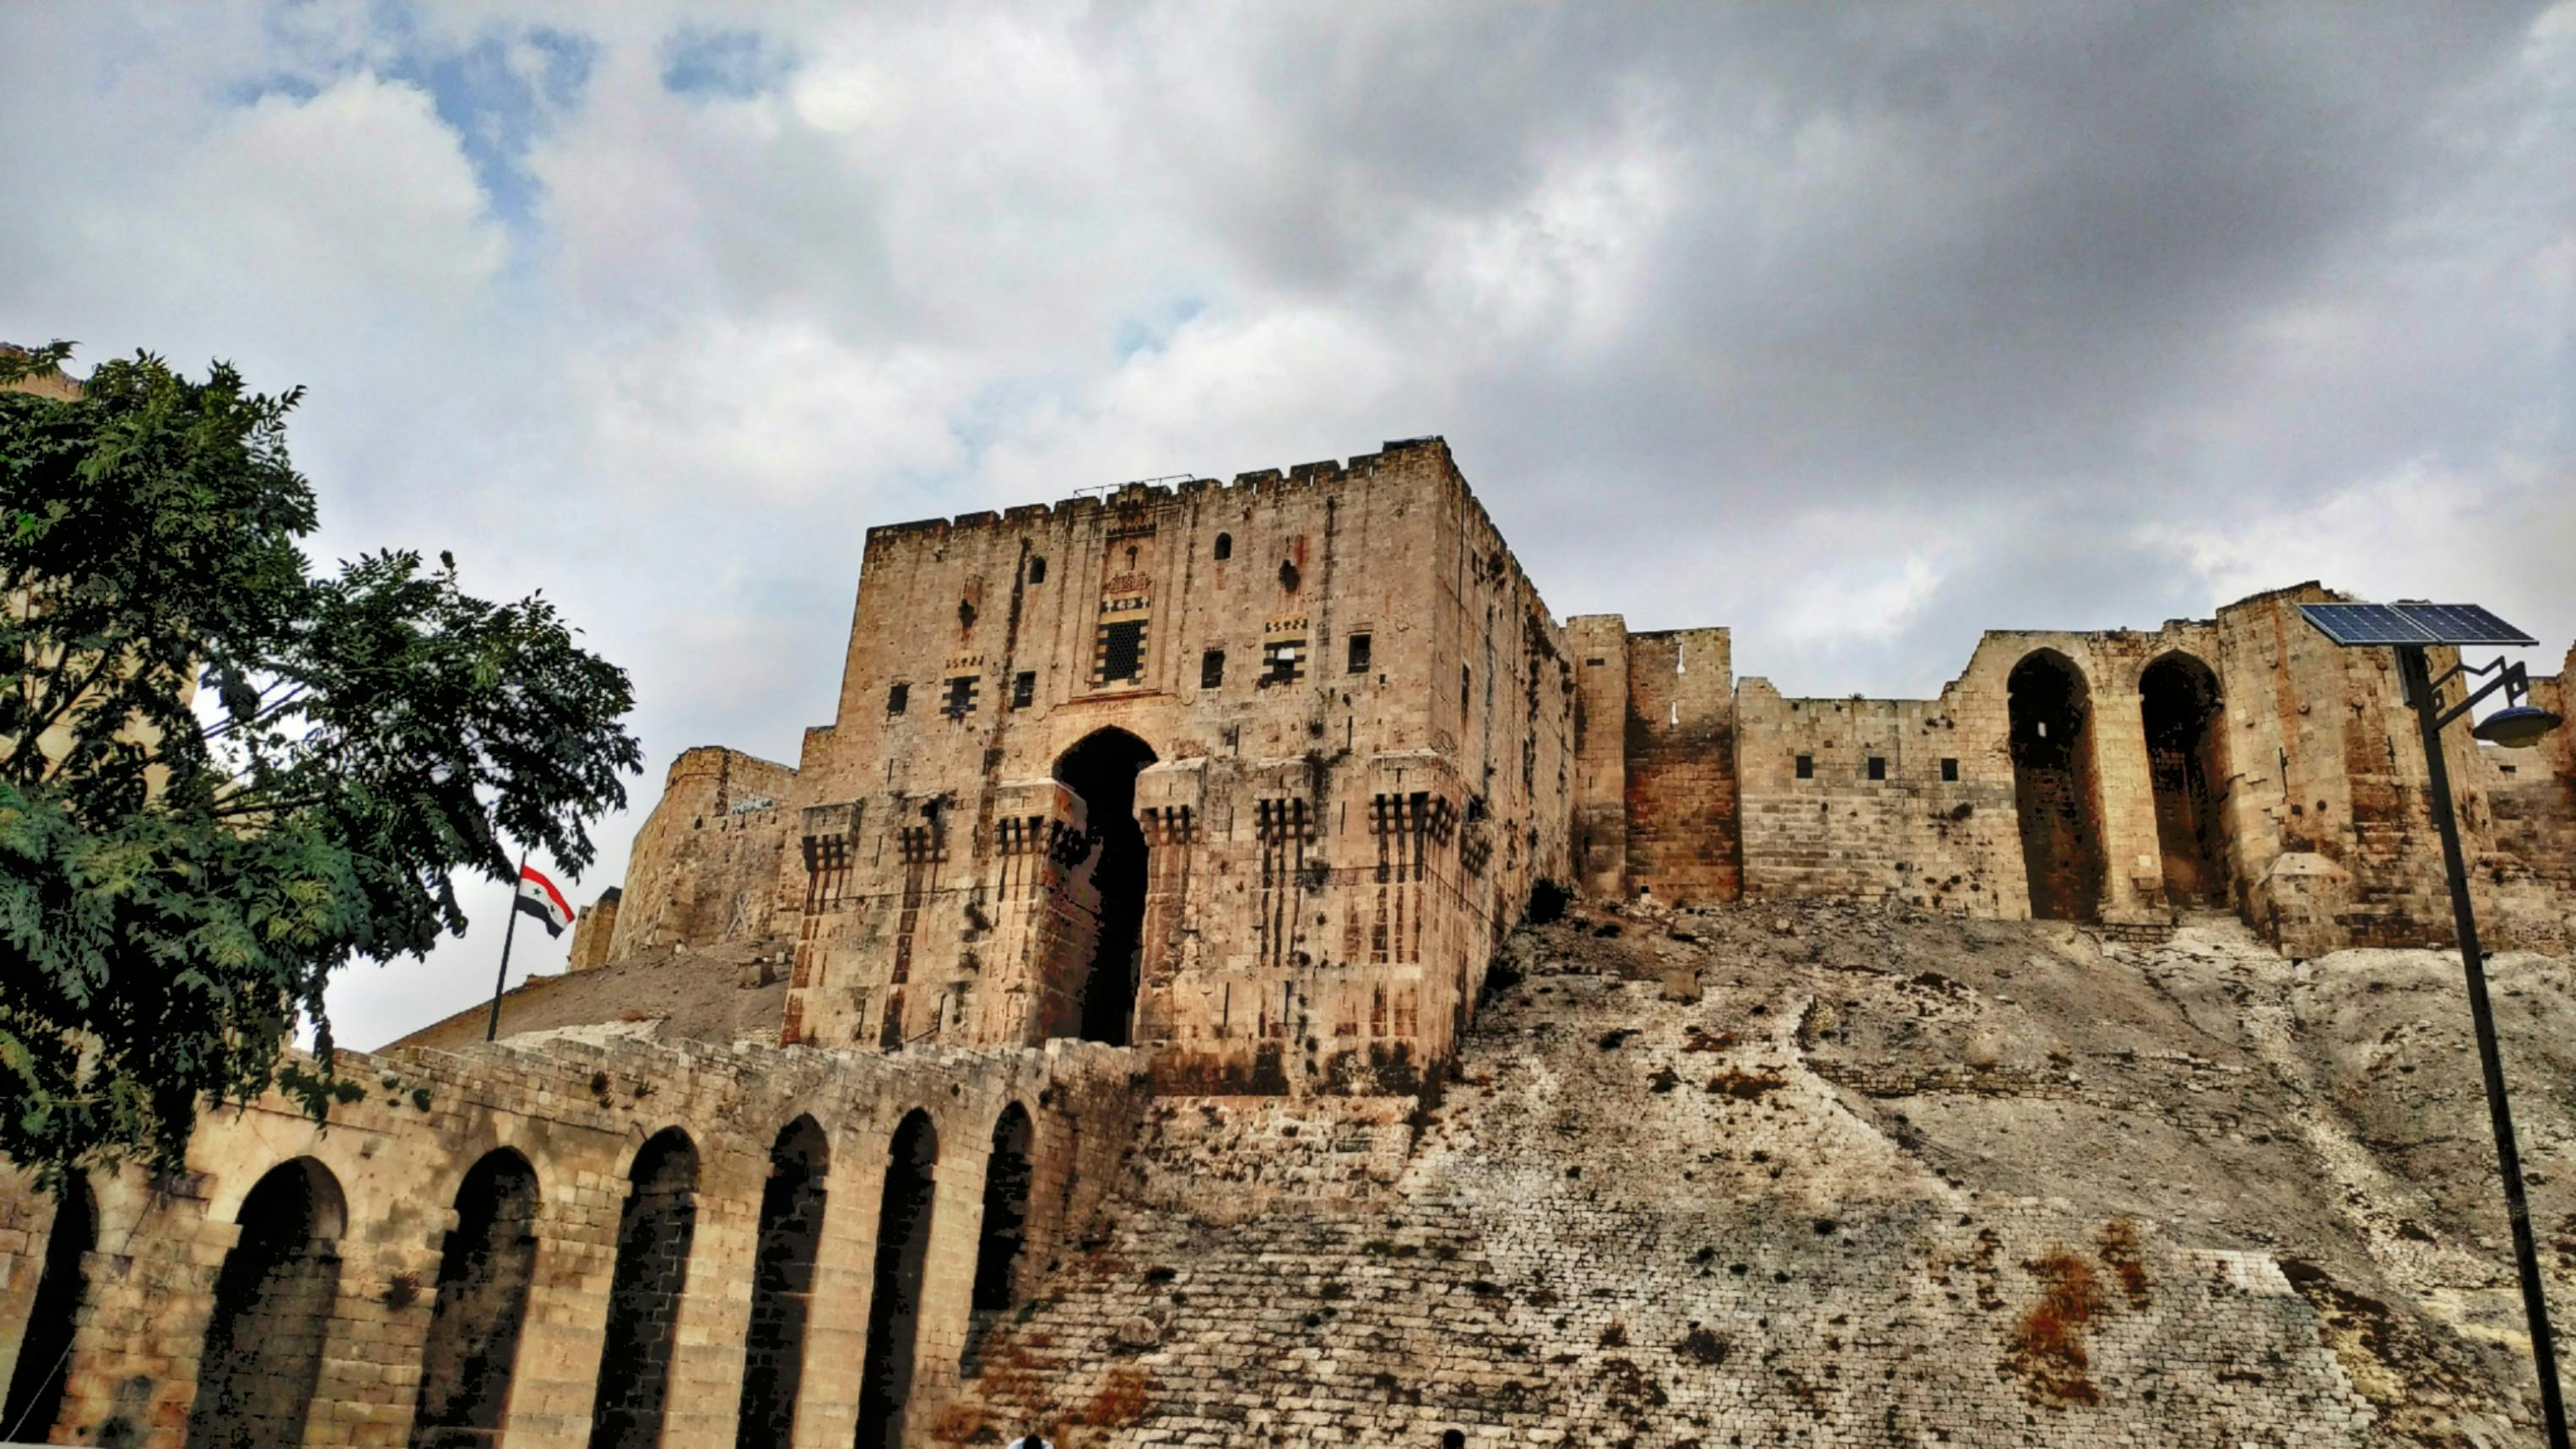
[2004,649,2108,922]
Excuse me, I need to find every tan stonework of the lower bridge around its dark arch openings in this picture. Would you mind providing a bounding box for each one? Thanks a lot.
[0,1042,1136,1449]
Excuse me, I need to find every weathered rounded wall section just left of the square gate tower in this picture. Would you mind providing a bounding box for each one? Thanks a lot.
[605,746,798,960]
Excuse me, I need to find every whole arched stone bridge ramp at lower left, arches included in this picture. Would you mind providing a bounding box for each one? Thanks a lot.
[0,1040,1141,1449]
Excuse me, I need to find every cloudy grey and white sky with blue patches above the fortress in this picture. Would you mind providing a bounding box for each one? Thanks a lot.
[0,0,2576,1045]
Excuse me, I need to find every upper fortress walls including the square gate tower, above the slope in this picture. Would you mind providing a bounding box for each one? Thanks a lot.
[589,441,2576,1070]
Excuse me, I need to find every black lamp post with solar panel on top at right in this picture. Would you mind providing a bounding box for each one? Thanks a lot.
[2297,594,2568,1449]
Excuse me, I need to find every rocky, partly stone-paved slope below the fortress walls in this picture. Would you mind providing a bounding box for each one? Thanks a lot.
[938,903,2576,1449]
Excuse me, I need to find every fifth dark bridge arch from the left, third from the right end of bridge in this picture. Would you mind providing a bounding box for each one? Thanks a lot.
[734,1117,832,1449]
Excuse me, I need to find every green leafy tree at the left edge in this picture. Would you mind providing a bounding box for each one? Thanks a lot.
[0,345,641,1179]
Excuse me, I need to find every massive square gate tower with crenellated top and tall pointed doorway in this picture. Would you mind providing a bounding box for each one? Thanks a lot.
[762,441,1574,1091]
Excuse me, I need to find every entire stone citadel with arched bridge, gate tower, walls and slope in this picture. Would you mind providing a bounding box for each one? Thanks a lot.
[0,441,2576,1449]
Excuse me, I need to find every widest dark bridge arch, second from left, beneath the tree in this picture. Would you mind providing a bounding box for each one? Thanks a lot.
[188,1158,348,1449]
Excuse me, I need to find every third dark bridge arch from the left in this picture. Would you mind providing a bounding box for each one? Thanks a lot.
[412,1148,538,1449]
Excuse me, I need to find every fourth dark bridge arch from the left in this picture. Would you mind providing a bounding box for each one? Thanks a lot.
[590,1127,698,1449]
